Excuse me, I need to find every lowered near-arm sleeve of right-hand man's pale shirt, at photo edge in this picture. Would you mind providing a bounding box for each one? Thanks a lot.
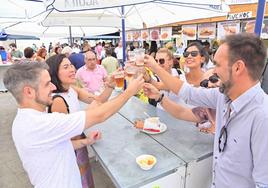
[251,116,268,187]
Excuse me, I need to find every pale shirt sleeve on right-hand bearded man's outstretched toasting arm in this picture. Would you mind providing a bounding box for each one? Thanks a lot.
[177,82,221,109]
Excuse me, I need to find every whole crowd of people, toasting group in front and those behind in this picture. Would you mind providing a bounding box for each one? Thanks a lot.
[4,34,268,188]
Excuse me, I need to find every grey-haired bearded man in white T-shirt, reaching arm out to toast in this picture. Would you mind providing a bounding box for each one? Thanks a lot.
[4,62,143,188]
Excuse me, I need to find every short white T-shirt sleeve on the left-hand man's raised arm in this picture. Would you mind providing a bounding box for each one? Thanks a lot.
[29,111,86,147]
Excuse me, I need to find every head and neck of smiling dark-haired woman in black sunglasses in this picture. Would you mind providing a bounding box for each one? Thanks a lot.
[183,42,208,87]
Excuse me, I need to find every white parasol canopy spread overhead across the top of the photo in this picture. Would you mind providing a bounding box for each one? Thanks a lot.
[0,0,229,37]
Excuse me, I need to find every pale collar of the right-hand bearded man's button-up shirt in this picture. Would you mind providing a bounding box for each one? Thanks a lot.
[228,82,261,113]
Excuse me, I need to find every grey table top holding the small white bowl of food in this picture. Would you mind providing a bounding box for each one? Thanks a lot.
[85,113,185,188]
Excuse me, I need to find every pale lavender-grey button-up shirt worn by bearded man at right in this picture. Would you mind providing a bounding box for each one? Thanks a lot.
[179,83,268,188]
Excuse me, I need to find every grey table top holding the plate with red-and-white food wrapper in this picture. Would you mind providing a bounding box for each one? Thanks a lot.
[119,97,214,163]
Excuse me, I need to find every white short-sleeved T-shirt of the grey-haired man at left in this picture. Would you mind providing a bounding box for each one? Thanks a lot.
[12,108,85,188]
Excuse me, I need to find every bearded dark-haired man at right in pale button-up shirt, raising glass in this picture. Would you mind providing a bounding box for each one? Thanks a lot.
[144,34,268,188]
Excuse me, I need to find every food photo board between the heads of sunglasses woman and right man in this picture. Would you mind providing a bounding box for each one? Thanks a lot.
[198,23,216,39]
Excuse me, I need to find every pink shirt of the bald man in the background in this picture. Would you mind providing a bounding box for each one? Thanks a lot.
[76,65,107,93]
